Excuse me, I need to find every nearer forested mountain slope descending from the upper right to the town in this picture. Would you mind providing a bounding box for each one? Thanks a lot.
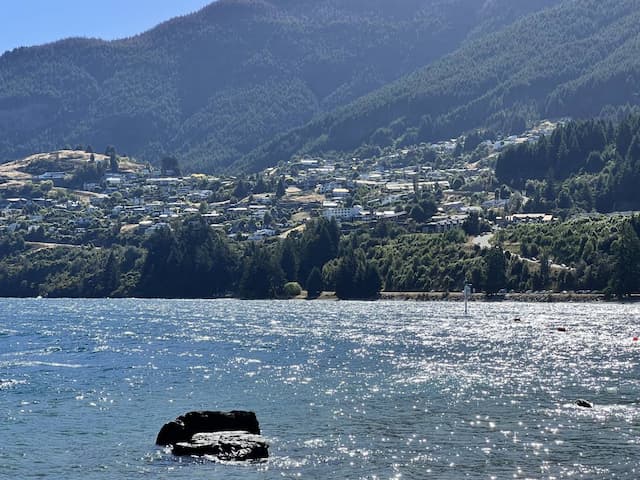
[240,0,640,169]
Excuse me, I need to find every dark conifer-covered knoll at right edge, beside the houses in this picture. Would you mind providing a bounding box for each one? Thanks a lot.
[496,114,640,212]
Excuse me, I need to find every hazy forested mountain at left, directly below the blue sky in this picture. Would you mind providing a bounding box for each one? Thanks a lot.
[0,0,560,171]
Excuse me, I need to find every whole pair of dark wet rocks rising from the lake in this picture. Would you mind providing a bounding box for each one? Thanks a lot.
[156,411,269,461]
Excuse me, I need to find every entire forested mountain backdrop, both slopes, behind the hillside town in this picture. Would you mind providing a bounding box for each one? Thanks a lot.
[6,0,640,172]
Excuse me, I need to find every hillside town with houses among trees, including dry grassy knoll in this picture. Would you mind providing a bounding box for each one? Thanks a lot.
[0,121,557,245]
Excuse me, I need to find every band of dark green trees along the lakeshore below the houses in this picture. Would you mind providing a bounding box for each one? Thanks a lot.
[0,214,640,300]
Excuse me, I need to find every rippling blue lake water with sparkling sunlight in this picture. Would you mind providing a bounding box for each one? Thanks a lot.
[0,299,640,480]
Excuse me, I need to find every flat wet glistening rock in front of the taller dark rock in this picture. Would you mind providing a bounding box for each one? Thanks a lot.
[172,432,269,462]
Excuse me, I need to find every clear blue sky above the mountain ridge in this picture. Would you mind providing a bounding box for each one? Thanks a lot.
[0,0,212,54]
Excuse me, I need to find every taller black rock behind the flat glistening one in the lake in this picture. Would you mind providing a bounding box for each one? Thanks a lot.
[156,411,260,445]
